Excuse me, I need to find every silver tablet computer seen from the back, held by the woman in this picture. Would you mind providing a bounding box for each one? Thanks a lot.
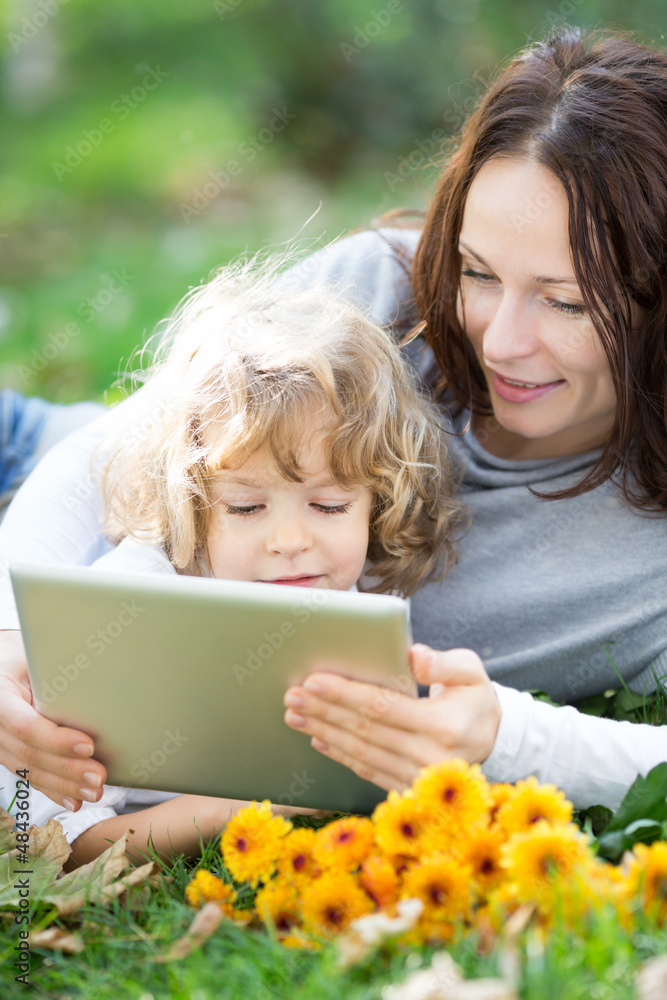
[11,566,416,813]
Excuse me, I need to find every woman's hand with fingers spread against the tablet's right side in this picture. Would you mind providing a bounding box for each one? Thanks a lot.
[285,645,500,791]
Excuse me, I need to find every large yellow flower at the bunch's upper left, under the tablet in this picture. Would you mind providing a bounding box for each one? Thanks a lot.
[220,800,292,888]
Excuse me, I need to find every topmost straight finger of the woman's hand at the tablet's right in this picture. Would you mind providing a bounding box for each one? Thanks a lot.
[285,673,422,738]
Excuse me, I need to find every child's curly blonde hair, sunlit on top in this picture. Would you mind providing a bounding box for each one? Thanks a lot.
[102,252,461,596]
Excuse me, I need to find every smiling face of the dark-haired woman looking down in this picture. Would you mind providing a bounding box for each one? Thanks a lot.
[458,157,616,459]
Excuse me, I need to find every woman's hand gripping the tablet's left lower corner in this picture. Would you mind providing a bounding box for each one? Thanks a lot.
[0,632,106,811]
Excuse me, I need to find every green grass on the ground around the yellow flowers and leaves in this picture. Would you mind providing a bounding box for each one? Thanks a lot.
[0,690,667,1000]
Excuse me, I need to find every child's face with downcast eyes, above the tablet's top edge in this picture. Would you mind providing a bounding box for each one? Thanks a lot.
[207,439,372,590]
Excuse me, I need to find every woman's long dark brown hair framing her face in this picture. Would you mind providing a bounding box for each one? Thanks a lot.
[413,28,667,513]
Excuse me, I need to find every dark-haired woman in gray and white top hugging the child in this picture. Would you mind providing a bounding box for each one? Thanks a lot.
[0,25,667,820]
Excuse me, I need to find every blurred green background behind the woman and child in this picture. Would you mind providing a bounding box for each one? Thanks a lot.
[0,0,667,402]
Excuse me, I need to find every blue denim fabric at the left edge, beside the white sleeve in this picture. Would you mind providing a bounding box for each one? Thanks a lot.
[0,389,54,495]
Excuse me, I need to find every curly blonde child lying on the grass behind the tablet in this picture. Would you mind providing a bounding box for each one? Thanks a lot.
[5,262,459,864]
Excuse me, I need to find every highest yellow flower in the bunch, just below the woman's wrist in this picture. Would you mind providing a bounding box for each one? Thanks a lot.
[412,760,491,850]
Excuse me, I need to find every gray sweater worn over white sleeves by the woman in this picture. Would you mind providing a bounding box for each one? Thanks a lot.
[290,230,667,702]
